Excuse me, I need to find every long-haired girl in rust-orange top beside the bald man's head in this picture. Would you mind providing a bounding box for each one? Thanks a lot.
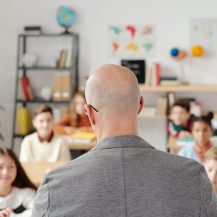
[54,91,92,135]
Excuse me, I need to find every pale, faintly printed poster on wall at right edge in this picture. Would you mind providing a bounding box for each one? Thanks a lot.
[191,18,217,55]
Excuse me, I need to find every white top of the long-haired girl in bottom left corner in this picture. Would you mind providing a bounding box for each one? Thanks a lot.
[0,187,36,217]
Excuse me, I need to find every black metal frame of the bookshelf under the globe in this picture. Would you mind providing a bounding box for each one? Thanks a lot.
[11,32,79,149]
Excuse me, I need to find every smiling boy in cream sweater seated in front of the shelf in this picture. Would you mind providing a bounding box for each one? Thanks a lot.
[20,105,71,162]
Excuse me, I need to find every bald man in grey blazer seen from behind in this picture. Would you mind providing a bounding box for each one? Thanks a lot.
[32,65,217,217]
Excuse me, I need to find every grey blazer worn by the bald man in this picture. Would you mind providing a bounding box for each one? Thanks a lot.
[32,136,217,217]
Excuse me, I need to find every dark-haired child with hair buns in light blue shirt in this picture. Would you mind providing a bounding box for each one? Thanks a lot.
[179,112,213,162]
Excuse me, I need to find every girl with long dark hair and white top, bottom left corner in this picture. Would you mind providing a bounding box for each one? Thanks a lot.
[0,147,36,217]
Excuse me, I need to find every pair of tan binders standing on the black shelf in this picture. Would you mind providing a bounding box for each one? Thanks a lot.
[53,72,71,101]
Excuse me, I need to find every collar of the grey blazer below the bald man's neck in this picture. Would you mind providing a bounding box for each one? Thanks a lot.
[91,135,155,151]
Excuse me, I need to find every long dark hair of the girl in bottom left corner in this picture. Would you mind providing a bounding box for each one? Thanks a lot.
[0,147,37,190]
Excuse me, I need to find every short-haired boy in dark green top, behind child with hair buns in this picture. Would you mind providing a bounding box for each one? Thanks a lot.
[167,100,192,154]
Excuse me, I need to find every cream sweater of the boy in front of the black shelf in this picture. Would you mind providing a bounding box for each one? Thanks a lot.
[20,133,71,163]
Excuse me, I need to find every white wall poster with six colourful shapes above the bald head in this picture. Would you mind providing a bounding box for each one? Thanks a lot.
[109,25,156,57]
